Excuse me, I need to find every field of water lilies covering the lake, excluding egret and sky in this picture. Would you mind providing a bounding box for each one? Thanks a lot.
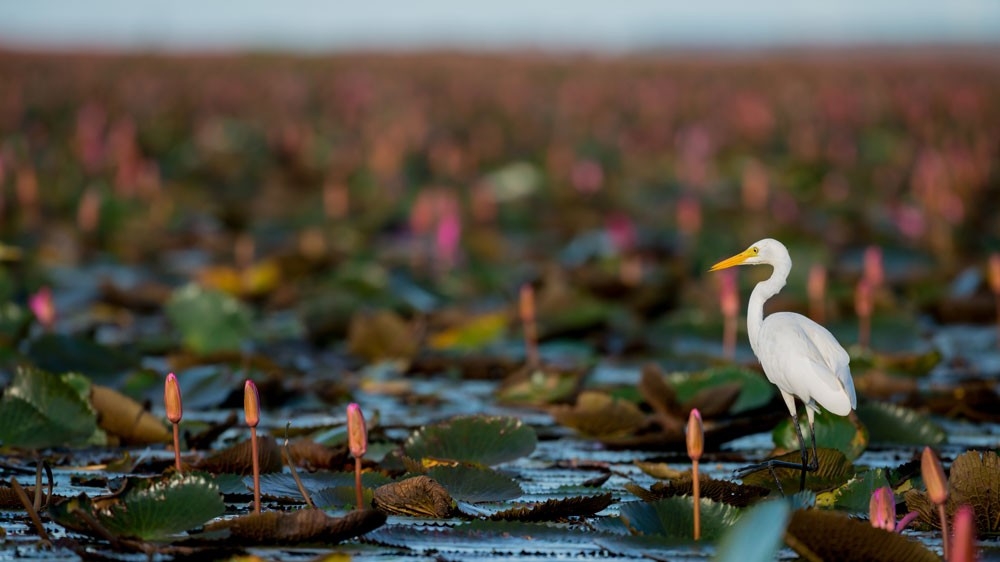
[0,48,1000,562]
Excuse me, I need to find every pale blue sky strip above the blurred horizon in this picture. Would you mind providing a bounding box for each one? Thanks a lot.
[0,0,1000,51]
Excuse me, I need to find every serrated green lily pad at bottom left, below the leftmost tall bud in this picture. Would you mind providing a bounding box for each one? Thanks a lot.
[97,474,226,540]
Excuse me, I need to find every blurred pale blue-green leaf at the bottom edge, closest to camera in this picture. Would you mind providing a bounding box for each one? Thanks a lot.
[715,499,792,562]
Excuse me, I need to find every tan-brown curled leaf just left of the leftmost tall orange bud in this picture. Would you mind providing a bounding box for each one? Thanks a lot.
[90,384,172,445]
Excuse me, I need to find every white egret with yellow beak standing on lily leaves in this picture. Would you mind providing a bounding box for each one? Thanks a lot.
[709,238,858,488]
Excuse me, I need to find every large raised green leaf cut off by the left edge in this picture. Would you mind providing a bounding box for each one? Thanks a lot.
[0,367,104,448]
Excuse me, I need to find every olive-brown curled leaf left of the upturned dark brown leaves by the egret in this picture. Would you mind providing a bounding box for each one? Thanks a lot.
[551,390,646,438]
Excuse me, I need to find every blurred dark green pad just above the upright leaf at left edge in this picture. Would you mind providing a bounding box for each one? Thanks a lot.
[26,334,138,384]
